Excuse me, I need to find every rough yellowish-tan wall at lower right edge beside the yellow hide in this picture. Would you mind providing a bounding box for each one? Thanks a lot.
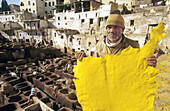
[154,54,170,111]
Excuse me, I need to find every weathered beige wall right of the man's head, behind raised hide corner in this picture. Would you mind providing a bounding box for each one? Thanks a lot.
[123,6,170,51]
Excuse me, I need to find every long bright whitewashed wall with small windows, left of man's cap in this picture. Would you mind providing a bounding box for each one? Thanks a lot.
[54,4,112,31]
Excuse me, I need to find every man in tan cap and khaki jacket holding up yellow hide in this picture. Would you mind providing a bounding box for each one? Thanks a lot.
[75,10,157,67]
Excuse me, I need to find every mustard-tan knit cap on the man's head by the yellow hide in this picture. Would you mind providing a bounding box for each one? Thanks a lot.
[106,14,125,28]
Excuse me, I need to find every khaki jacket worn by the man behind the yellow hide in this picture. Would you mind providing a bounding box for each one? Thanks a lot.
[93,35,139,57]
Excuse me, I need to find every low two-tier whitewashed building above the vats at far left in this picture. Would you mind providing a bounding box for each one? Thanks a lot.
[17,19,48,43]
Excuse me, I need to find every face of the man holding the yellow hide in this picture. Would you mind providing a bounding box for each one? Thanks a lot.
[106,25,124,43]
